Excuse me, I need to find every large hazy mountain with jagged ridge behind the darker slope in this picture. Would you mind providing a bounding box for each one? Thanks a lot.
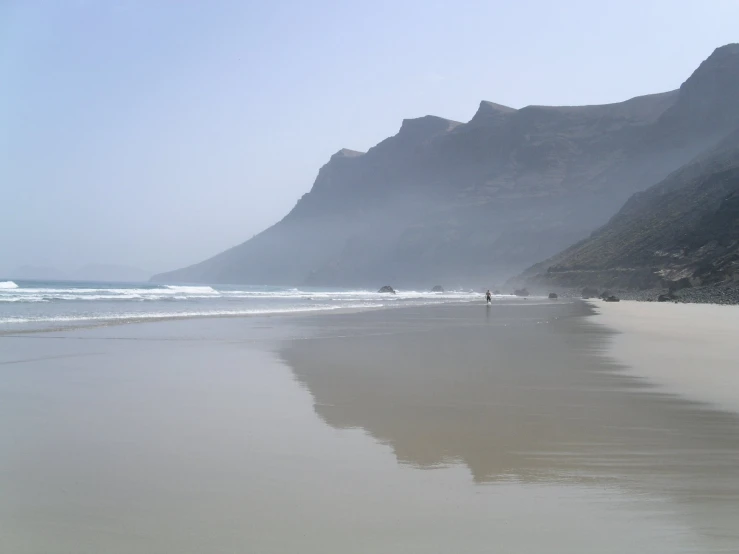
[153,44,739,286]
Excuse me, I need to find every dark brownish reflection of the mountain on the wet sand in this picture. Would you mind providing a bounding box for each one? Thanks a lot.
[281,302,739,545]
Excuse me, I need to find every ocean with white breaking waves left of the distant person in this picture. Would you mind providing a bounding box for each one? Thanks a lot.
[0,280,481,333]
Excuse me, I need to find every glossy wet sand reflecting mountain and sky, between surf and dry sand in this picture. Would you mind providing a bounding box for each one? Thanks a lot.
[0,301,739,554]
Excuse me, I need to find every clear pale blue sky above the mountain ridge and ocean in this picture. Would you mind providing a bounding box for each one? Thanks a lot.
[0,0,739,276]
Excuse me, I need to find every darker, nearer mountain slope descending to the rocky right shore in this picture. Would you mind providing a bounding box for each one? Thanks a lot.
[523,129,739,288]
